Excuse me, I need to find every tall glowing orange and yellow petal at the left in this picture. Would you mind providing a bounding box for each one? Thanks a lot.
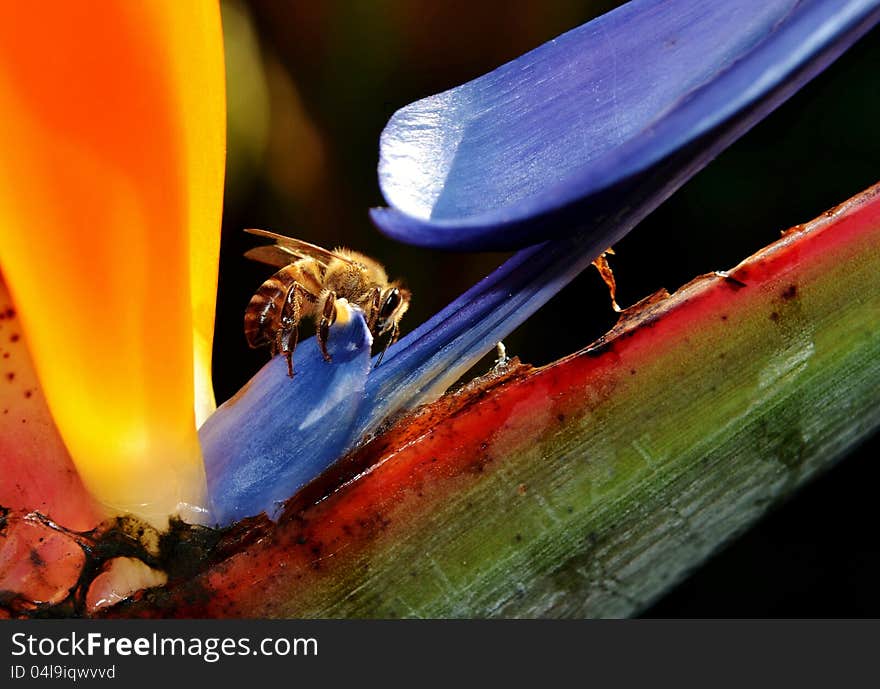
[0,0,225,524]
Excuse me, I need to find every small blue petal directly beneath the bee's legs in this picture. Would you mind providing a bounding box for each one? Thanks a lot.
[199,310,372,525]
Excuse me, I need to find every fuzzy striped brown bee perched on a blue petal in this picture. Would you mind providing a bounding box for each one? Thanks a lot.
[244,230,410,378]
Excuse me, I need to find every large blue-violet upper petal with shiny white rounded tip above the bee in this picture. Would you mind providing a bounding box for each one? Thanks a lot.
[372,0,880,250]
